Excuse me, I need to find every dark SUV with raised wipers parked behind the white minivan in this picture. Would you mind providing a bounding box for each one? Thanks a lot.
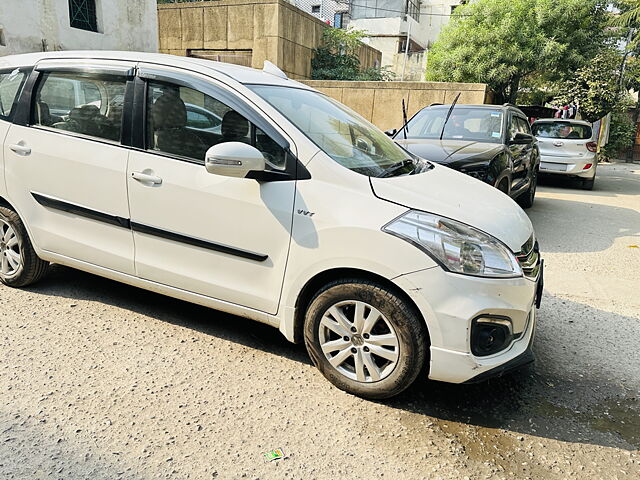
[393,105,540,208]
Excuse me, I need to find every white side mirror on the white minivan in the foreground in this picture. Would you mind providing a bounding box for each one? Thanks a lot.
[204,142,265,178]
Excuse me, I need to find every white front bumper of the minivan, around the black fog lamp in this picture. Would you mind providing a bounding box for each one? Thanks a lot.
[394,267,542,383]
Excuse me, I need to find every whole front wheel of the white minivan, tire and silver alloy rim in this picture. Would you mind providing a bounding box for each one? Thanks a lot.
[304,278,429,399]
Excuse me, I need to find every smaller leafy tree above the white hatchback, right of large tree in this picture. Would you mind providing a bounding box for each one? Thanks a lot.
[554,50,627,122]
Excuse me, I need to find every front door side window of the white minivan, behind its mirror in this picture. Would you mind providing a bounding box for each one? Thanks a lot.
[146,82,286,170]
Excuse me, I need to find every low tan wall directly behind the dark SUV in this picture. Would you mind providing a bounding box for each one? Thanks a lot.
[303,80,493,130]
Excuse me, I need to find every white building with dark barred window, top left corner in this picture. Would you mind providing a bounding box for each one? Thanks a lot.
[0,0,158,55]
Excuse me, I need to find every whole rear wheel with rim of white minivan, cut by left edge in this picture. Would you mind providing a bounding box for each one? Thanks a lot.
[0,207,49,287]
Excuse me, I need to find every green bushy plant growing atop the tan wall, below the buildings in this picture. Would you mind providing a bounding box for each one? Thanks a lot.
[311,28,393,80]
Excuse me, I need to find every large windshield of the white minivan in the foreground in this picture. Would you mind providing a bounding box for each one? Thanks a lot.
[249,85,430,177]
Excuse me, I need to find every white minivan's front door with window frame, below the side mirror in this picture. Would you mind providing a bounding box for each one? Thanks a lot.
[128,66,295,314]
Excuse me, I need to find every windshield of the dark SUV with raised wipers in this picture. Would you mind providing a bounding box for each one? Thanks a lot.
[397,105,503,143]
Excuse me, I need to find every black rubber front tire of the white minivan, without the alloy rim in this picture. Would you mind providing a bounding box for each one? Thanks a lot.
[304,278,429,399]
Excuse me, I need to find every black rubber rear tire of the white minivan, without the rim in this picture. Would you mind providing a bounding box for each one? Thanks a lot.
[0,206,49,288]
